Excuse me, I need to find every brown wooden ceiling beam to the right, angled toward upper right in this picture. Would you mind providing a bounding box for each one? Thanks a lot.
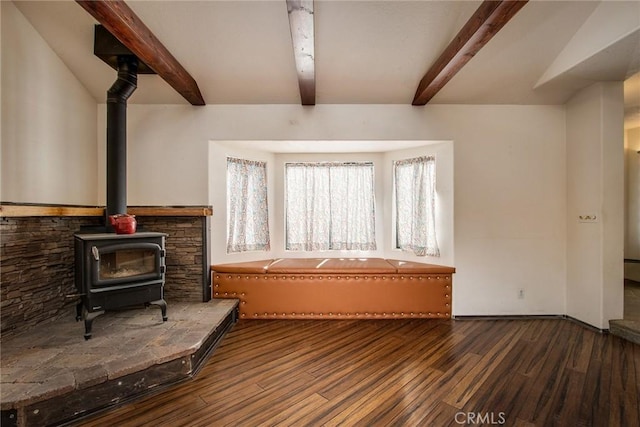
[412,0,528,105]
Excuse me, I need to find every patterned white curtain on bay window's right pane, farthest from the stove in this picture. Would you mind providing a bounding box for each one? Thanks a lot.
[394,156,440,256]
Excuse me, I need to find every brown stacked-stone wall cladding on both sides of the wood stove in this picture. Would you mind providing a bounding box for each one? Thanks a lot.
[0,217,210,337]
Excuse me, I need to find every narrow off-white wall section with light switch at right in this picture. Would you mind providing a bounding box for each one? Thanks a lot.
[567,82,624,329]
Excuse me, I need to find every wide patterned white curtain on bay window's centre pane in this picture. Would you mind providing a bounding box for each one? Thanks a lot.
[285,162,376,251]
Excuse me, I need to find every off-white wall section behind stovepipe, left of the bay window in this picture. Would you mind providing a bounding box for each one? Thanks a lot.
[96,106,209,206]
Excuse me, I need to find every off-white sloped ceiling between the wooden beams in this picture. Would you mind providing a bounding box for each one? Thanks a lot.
[8,0,640,124]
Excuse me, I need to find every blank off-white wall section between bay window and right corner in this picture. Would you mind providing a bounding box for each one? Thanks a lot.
[438,106,566,315]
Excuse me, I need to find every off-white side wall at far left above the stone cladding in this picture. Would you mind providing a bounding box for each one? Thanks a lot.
[0,1,97,205]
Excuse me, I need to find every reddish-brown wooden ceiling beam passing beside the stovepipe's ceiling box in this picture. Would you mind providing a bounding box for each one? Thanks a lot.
[76,0,205,105]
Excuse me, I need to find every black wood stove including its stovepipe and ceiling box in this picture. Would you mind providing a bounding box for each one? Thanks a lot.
[75,25,167,339]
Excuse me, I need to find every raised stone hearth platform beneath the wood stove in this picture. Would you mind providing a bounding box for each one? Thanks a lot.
[0,300,238,427]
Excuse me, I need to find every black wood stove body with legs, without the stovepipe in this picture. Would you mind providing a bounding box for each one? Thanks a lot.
[75,232,167,339]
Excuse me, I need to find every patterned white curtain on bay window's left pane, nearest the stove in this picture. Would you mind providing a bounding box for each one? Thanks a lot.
[227,157,270,253]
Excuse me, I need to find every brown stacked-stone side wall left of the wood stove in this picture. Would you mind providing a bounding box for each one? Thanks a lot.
[0,217,100,338]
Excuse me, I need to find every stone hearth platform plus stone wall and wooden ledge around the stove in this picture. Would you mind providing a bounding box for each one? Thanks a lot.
[0,203,220,427]
